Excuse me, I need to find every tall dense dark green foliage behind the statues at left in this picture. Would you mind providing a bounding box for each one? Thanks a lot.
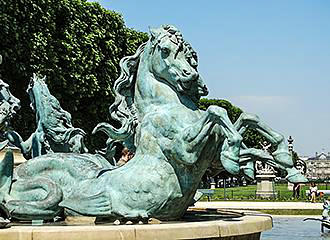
[0,0,148,150]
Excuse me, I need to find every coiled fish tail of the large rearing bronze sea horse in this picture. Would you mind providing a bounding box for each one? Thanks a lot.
[4,177,63,220]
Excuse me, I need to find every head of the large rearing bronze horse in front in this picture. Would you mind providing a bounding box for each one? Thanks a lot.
[149,25,208,100]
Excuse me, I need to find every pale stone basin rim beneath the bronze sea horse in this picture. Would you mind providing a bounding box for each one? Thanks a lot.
[0,216,272,240]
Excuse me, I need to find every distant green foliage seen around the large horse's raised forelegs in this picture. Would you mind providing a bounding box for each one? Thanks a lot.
[198,98,266,148]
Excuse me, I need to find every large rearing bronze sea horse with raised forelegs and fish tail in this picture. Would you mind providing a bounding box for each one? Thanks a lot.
[0,25,305,220]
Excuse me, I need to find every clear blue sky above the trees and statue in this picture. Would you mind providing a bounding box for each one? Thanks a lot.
[93,0,330,156]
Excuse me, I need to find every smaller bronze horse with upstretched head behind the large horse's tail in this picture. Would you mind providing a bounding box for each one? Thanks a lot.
[7,74,88,159]
